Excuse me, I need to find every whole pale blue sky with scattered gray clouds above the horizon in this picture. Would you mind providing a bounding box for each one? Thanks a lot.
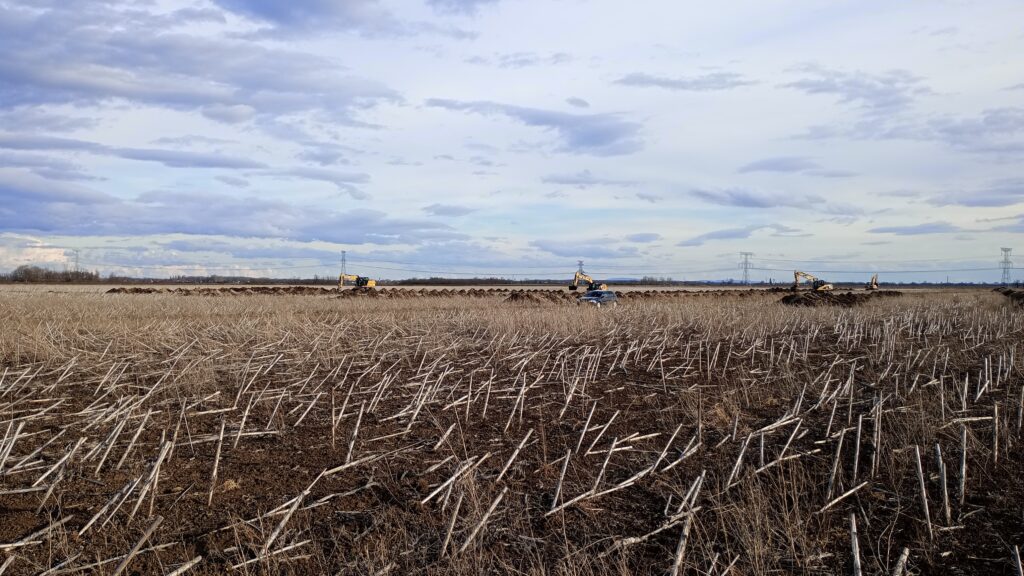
[0,0,1024,282]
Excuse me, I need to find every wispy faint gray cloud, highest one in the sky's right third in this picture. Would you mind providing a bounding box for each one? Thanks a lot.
[783,65,931,114]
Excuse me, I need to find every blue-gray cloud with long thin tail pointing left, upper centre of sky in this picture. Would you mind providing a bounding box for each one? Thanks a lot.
[426,98,642,156]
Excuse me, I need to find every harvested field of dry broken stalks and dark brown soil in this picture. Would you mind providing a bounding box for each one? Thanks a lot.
[0,287,1024,576]
